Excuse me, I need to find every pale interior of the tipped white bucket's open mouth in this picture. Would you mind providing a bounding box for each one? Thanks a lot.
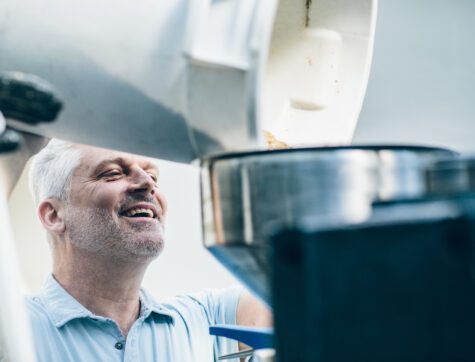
[260,0,377,147]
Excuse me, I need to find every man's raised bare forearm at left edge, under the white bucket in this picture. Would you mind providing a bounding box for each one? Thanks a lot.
[0,132,48,196]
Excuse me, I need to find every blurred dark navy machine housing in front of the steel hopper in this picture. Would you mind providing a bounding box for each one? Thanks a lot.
[272,158,475,361]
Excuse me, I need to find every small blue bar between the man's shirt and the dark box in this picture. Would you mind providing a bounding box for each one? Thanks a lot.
[209,324,274,349]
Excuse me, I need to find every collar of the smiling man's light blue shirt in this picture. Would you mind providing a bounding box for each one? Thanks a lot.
[39,275,175,328]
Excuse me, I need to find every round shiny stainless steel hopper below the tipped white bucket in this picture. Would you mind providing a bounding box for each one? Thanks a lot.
[201,146,456,304]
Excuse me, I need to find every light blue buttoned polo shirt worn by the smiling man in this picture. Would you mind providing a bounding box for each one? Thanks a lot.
[27,276,242,362]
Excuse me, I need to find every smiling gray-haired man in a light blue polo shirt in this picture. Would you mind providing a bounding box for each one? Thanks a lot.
[5,140,270,362]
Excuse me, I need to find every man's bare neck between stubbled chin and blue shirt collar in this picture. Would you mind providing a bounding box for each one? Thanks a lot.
[53,245,149,336]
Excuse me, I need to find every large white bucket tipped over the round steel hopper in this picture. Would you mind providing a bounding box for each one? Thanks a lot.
[0,0,376,162]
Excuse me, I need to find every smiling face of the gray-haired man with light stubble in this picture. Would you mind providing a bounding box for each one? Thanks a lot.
[65,146,166,260]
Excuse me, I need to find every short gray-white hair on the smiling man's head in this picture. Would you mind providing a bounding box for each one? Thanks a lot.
[29,138,81,205]
